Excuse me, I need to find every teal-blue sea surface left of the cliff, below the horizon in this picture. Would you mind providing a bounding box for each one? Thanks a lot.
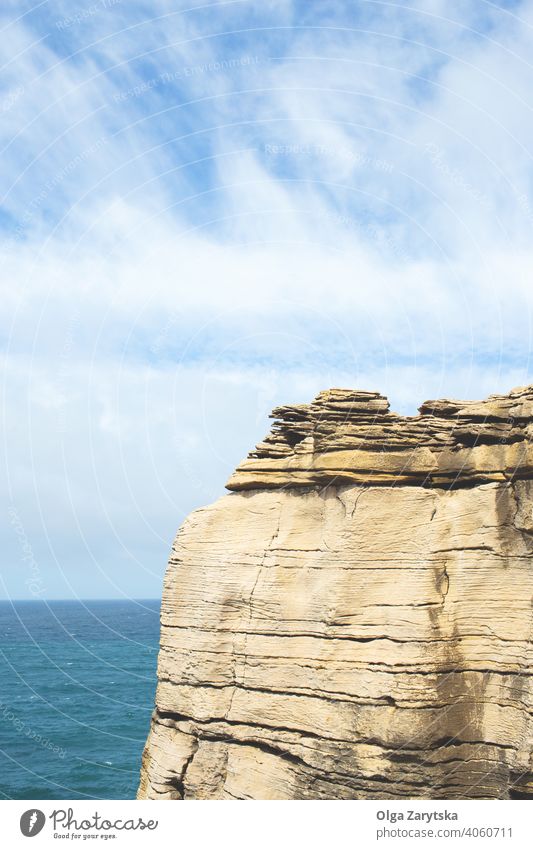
[0,601,160,799]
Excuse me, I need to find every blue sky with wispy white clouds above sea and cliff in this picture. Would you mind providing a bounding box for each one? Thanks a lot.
[0,0,533,599]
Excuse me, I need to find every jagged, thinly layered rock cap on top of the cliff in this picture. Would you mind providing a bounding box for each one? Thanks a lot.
[227,386,533,490]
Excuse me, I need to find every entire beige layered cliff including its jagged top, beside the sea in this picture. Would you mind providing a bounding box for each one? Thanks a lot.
[139,387,533,799]
